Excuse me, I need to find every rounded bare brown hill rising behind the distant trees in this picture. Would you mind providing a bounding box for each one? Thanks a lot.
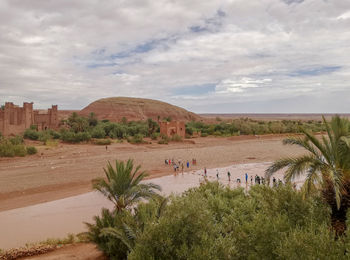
[79,97,201,122]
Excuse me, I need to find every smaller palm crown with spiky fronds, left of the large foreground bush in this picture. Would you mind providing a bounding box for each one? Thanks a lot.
[93,159,161,211]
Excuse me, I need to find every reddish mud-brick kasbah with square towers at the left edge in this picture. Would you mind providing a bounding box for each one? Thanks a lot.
[0,102,59,136]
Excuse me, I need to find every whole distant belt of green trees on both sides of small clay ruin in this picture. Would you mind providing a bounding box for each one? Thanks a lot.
[20,113,325,144]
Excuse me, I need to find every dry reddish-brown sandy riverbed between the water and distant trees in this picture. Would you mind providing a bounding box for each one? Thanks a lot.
[0,136,302,211]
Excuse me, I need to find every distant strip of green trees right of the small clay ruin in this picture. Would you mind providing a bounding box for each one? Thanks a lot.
[186,118,325,137]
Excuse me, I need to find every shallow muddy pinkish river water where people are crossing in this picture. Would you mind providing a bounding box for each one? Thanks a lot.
[0,163,300,249]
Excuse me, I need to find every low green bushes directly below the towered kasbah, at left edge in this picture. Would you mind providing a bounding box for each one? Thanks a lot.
[0,136,37,157]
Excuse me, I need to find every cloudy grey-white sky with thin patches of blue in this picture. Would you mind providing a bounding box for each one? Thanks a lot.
[0,0,350,113]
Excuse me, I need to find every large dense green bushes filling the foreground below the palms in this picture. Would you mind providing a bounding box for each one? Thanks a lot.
[90,182,350,259]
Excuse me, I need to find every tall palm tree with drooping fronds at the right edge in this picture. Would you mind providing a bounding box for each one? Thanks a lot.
[265,116,350,235]
